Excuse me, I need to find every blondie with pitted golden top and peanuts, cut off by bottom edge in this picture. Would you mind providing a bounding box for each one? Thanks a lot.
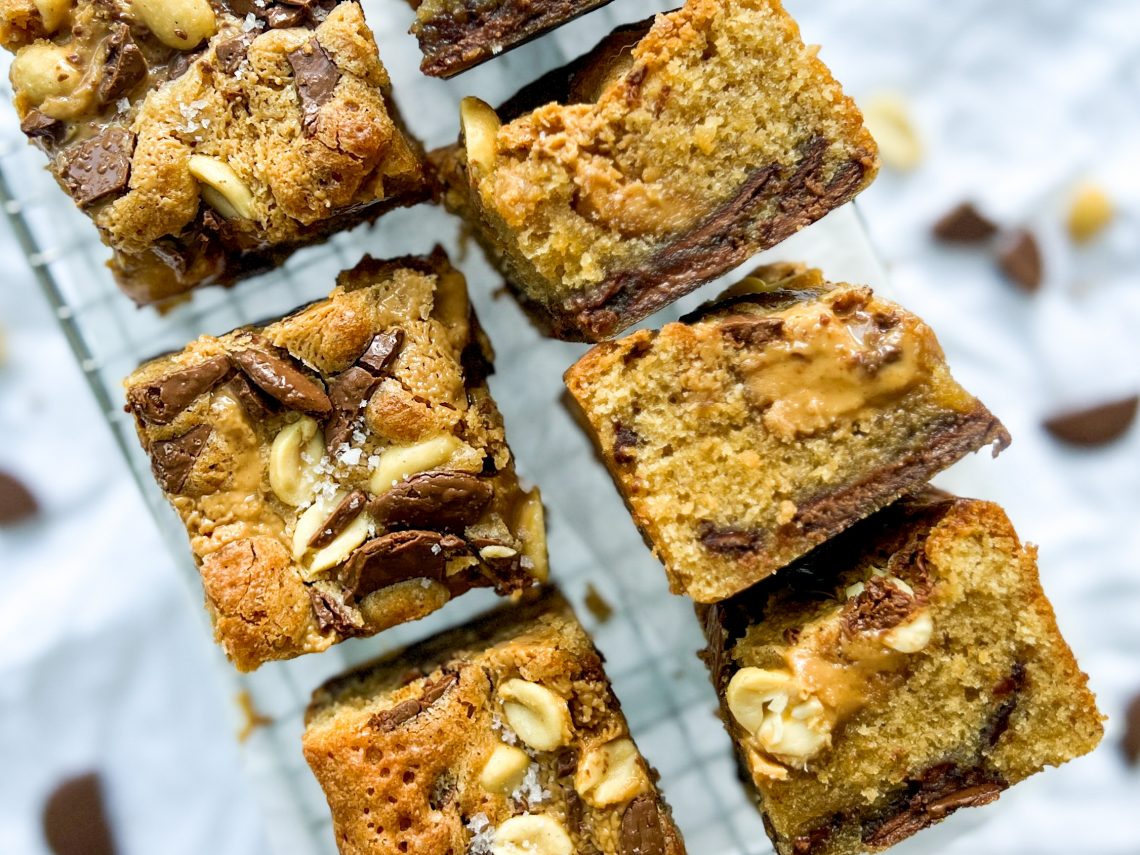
[303,592,684,855]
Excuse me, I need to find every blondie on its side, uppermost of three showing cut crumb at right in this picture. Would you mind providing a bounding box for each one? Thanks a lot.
[432,0,878,341]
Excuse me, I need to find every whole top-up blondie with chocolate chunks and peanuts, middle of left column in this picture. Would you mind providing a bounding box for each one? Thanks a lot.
[127,250,547,670]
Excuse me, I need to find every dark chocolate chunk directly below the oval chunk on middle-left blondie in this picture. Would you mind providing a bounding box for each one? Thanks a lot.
[341,531,466,600]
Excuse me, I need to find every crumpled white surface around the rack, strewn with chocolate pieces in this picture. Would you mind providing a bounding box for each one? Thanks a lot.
[0,0,1140,855]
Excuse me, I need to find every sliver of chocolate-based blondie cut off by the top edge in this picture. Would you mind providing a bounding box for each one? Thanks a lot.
[409,0,612,78]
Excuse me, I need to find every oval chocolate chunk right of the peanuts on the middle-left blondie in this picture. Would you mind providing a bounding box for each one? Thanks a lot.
[368,470,495,531]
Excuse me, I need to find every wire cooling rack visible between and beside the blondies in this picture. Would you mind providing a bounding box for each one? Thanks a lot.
[0,0,916,855]
